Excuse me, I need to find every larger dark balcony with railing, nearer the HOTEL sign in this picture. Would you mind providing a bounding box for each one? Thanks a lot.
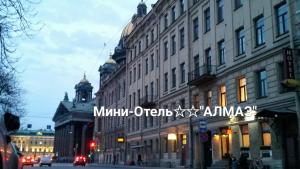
[188,65,216,86]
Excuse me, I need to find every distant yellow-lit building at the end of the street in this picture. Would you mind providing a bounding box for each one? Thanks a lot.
[11,129,54,159]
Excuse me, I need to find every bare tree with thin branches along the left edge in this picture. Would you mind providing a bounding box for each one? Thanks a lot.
[0,0,37,115]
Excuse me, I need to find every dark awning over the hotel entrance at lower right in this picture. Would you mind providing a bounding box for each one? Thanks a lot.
[256,108,297,118]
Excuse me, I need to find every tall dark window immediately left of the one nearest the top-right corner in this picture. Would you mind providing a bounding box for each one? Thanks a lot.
[254,16,265,46]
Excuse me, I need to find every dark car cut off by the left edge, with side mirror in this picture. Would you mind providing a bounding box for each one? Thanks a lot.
[0,113,22,169]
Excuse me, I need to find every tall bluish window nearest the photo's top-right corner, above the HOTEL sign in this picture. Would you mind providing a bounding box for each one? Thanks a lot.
[275,2,289,36]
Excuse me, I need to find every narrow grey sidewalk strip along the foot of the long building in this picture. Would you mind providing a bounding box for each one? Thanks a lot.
[88,163,184,169]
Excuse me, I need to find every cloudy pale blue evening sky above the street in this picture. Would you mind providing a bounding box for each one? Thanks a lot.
[15,0,157,129]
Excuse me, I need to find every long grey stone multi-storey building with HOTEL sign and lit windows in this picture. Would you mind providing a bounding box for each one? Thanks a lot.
[94,0,300,168]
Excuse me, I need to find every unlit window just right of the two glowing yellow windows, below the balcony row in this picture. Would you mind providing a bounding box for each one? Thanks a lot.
[257,70,268,97]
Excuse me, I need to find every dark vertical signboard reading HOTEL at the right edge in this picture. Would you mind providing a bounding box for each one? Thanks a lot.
[283,48,295,79]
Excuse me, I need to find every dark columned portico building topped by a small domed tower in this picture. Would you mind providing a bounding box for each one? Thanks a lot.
[52,74,95,162]
